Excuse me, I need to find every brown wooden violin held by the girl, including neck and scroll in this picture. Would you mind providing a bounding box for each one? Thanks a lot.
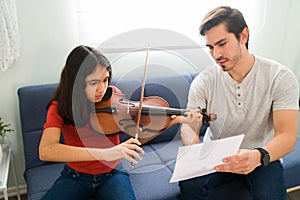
[90,87,216,141]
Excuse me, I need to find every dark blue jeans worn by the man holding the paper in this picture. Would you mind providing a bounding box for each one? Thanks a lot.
[179,161,286,200]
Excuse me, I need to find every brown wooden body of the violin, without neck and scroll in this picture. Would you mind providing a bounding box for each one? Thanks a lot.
[91,93,170,135]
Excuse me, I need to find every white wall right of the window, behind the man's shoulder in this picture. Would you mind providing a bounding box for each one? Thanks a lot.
[250,0,300,76]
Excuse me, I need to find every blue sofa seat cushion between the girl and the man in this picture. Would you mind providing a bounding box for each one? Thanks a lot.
[122,139,181,200]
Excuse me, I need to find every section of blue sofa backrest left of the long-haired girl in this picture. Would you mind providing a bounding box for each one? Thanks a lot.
[18,84,57,169]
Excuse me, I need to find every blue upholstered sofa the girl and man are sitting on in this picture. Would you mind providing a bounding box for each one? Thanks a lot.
[18,73,300,200]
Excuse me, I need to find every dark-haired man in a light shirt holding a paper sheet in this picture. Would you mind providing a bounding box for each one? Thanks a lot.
[179,7,299,200]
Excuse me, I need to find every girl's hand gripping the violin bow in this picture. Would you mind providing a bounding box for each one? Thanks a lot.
[101,138,145,164]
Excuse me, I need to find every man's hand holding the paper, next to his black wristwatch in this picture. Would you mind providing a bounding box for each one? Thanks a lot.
[214,149,261,174]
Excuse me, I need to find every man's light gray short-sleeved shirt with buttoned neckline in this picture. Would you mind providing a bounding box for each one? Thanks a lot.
[187,56,299,149]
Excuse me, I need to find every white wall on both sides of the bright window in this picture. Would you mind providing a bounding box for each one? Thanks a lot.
[0,0,300,194]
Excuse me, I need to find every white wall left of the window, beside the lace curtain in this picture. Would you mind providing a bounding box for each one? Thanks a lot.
[0,0,78,191]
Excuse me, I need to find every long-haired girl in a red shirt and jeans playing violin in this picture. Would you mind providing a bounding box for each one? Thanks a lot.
[39,46,144,200]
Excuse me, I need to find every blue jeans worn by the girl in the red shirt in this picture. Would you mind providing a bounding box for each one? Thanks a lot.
[43,164,135,200]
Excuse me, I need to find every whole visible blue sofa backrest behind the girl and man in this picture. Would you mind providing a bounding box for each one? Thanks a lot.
[18,73,197,169]
